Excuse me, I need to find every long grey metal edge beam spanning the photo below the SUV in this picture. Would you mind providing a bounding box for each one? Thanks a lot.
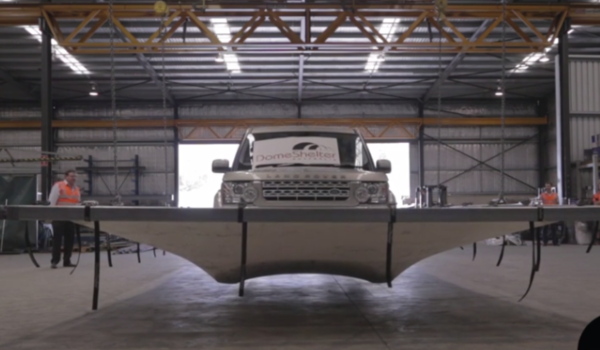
[7,206,600,223]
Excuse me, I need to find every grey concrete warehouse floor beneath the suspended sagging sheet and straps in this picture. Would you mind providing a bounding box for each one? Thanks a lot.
[0,245,600,350]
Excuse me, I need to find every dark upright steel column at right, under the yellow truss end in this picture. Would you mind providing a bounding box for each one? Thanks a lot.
[556,19,573,204]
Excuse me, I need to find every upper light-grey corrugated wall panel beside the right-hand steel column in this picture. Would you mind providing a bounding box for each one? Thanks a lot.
[569,57,600,114]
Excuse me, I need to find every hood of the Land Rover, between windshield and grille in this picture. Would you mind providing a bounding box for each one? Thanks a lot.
[223,166,388,182]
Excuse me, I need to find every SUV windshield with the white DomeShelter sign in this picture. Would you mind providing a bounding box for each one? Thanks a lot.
[236,131,373,170]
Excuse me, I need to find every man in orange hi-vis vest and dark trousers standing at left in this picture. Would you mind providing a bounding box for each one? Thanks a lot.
[49,170,81,269]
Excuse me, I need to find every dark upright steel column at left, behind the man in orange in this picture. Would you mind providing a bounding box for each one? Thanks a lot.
[40,18,54,202]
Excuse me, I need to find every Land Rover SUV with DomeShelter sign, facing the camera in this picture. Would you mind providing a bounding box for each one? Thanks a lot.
[212,126,395,208]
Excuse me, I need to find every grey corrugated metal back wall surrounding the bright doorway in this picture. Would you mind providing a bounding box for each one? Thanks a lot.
[0,100,538,201]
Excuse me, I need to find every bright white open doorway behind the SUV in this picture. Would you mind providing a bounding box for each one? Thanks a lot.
[179,142,410,208]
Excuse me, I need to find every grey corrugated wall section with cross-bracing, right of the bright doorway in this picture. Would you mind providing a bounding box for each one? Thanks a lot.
[424,127,539,195]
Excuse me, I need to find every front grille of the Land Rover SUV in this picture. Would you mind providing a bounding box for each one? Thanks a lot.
[262,181,350,201]
